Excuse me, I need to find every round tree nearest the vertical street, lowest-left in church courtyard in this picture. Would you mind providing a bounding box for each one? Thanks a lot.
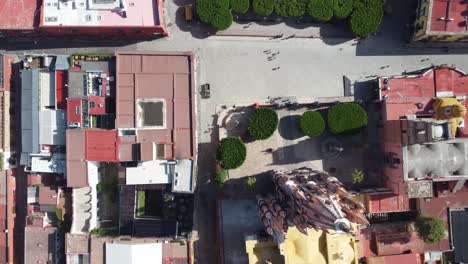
[217,137,247,170]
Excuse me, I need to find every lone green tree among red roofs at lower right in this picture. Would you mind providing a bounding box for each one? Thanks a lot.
[415,216,445,244]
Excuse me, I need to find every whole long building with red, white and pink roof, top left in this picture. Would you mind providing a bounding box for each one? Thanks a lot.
[0,0,167,38]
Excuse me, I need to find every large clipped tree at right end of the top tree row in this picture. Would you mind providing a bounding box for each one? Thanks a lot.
[350,0,384,37]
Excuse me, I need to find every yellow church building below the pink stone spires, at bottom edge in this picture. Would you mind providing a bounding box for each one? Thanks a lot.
[245,227,358,264]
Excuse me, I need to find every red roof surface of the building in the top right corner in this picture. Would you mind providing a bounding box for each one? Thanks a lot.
[429,0,468,32]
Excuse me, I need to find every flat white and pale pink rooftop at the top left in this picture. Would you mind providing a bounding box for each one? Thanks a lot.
[41,0,159,27]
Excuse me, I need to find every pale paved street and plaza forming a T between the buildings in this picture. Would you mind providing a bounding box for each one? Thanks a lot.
[4,1,468,264]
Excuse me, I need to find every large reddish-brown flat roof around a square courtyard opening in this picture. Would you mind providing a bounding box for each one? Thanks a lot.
[116,52,196,159]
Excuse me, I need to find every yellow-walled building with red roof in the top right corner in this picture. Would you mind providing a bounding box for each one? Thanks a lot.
[413,0,468,42]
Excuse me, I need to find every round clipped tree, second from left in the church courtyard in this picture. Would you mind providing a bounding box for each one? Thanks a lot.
[249,107,278,140]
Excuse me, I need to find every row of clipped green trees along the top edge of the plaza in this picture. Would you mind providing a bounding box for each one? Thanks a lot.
[197,0,384,37]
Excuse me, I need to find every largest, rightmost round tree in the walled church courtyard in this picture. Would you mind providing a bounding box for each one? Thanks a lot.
[328,103,367,134]
